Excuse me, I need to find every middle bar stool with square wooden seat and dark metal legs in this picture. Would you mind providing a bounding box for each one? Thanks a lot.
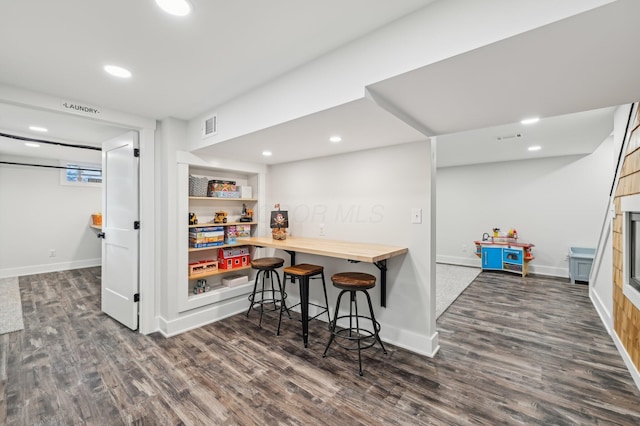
[277,263,331,348]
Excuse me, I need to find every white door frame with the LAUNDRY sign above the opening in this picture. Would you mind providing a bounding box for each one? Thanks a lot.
[0,84,160,334]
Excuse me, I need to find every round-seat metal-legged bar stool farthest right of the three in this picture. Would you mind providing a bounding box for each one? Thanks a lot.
[322,272,387,376]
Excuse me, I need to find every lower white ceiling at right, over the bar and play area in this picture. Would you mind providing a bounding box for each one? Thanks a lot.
[191,0,640,167]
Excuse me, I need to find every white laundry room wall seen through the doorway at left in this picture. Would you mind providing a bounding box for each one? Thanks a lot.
[0,156,102,277]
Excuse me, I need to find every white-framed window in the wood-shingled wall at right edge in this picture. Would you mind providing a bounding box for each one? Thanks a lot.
[620,195,640,309]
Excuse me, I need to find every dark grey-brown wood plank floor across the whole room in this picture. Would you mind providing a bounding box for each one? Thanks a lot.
[0,268,640,425]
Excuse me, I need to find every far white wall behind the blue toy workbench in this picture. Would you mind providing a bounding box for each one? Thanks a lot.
[436,138,613,277]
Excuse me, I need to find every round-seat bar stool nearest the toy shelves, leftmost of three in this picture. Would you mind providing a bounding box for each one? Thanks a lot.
[247,257,287,327]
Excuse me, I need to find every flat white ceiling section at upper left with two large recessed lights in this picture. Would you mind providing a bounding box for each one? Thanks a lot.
[0,0,433,120]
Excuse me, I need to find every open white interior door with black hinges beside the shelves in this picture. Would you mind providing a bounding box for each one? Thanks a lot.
[102,132,139,330]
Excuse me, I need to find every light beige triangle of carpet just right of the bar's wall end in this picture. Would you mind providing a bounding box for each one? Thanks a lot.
[436,263,481,319]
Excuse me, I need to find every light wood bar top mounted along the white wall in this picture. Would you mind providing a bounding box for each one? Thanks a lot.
[242,236,409,263]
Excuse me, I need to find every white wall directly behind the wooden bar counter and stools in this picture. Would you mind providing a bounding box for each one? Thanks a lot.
[267,142,437,355]
